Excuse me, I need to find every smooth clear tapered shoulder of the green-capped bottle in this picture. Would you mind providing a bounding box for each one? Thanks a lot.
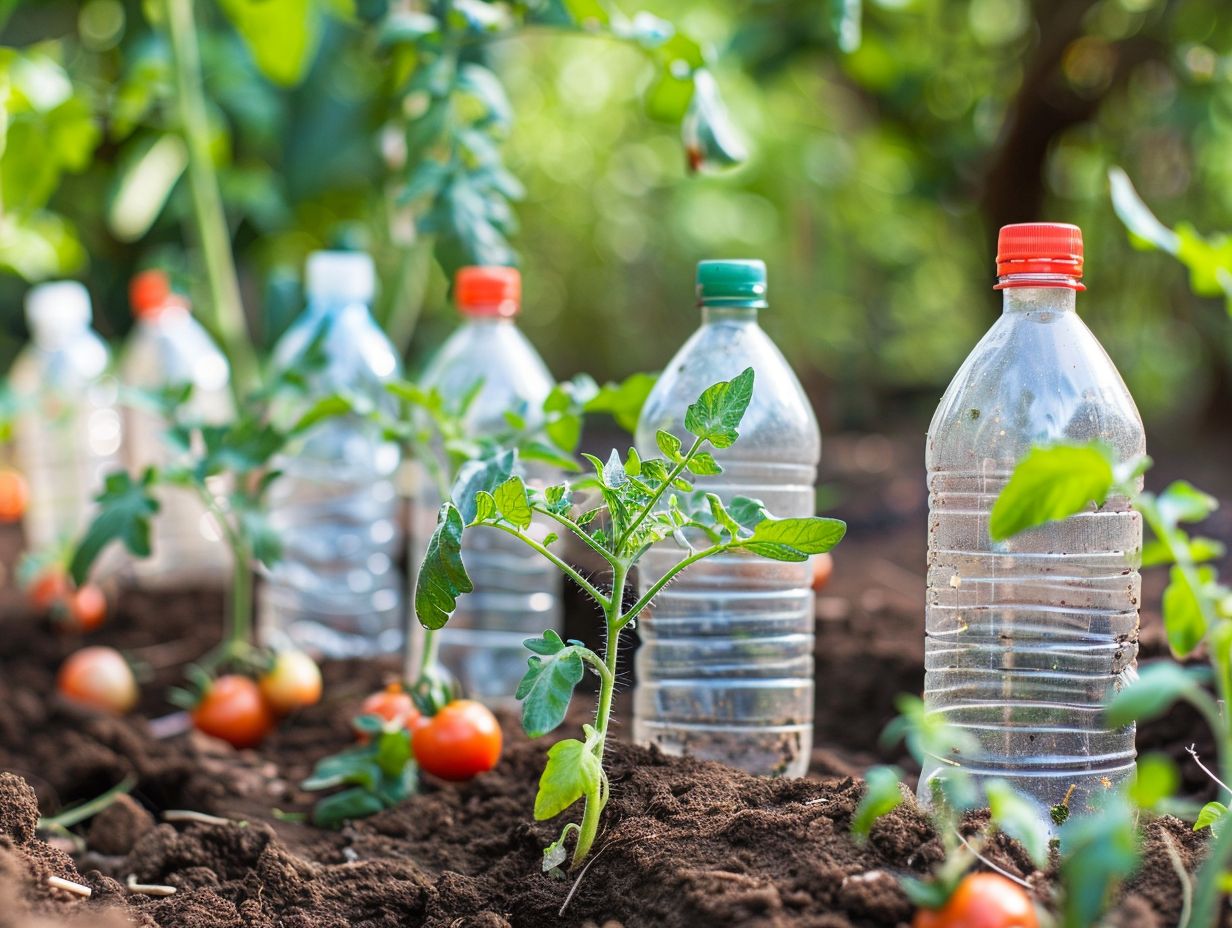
[637,323,822,465]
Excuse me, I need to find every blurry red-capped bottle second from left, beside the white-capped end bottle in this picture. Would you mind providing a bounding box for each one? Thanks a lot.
[121,271,234,587]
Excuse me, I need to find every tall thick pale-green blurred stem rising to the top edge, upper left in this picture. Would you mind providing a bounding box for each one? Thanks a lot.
[165,0,257,401]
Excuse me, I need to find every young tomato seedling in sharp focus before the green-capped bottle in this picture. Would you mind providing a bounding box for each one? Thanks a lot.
[415,368,846,870]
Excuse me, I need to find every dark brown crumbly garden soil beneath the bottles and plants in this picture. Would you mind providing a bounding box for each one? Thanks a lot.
[0,431,1232,928]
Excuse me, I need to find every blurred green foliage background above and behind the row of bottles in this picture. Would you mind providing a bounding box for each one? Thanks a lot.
[0,0,1232,436]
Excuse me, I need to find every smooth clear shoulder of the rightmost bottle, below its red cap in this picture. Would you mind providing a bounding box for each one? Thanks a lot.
[925,312,1146,471]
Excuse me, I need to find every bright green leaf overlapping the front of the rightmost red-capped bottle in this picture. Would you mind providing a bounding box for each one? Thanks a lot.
[988,442,1114,541]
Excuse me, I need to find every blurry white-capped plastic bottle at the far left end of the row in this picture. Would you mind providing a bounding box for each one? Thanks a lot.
[10,281,123,554]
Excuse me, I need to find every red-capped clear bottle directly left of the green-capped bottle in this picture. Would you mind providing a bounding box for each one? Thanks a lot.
[414,267,562,702]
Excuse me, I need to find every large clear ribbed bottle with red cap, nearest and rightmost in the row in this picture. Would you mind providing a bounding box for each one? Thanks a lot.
[919,223,1146,821]
